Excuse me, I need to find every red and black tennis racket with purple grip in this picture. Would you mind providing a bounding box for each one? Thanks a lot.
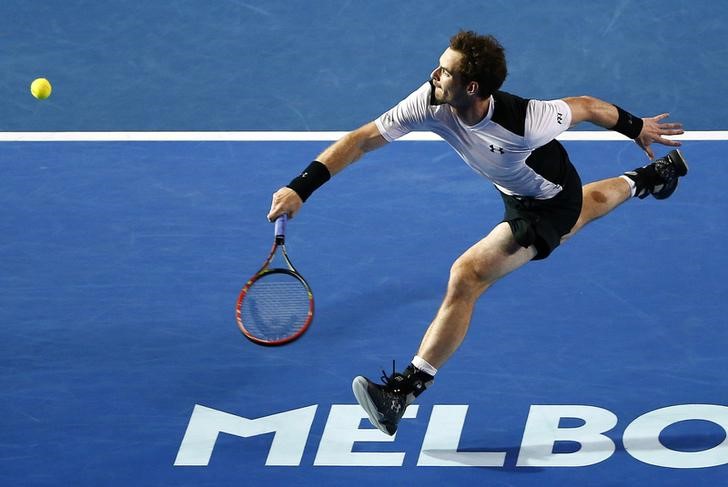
[235,215,313,345]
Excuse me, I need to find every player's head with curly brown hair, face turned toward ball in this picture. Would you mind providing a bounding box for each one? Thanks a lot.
[432,31,508,105]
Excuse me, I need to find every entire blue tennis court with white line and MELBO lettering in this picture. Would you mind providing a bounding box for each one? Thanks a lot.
[0,0,728,487]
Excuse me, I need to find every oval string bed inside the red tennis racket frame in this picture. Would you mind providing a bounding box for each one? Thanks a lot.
[242,273,310,341]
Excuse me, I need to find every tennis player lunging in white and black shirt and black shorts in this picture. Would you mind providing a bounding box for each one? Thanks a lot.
[268,31,688,435]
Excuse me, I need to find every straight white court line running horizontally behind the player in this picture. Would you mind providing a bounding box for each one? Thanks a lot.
[0,130,728,142]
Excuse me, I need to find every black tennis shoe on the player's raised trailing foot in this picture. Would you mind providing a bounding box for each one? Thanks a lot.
[624,149,688,200]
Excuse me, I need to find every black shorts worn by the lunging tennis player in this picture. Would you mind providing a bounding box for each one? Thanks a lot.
[501,143,582,260]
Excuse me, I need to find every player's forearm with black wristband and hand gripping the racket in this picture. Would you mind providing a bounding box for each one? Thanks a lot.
[268,122,387,221]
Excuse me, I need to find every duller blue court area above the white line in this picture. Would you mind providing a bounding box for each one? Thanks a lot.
[0,0,728,131]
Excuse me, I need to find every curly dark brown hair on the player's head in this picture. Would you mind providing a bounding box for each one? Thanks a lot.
[450,30,508,98]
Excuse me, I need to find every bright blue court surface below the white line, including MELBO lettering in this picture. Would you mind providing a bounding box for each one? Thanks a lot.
[0,137,728,486]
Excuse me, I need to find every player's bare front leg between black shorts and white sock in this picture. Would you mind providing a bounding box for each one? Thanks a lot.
[417,223,536,368]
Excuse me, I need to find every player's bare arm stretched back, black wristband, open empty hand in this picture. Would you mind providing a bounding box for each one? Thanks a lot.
[564,96,684,159]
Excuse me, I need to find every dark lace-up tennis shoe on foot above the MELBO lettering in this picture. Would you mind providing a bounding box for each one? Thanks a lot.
[351,369,432,436]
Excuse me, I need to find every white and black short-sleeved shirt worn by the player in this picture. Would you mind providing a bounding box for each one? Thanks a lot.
[375,82,571,199]
